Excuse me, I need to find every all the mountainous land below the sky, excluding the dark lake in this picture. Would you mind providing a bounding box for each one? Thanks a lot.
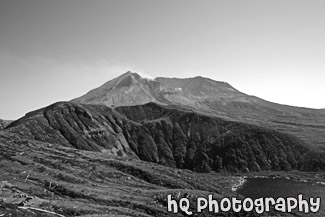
[0,72,325,217]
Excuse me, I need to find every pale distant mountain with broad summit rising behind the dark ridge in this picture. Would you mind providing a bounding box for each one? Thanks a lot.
[72,72,325,150]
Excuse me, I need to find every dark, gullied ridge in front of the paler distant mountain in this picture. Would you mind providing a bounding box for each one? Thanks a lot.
[5,103,325,172]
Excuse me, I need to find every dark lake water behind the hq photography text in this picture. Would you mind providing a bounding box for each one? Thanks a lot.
[237,178,325,217]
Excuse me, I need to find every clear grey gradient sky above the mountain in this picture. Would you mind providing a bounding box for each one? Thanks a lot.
[0,0,325,120]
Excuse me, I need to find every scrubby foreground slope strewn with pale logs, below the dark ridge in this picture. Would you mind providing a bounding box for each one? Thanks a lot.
[0,132,246,217]
